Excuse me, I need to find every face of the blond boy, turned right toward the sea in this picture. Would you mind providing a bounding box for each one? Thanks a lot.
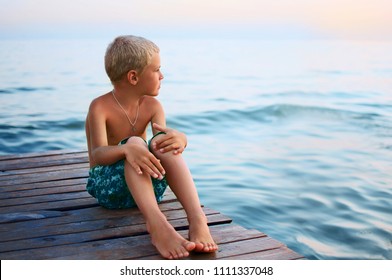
[138,53,163,96]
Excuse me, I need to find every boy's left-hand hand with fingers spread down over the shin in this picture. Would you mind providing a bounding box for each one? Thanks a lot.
[123,141,165,180]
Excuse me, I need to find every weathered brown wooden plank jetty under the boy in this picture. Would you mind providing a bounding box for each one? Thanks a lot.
[0,151,303,260]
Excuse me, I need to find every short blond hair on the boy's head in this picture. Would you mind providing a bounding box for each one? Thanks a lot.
[105,35,159,83]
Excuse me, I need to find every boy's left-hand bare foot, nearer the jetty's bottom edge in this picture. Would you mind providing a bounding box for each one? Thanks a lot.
[147,221,196,259]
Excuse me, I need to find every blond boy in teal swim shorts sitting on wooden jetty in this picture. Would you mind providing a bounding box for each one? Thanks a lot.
[86,36,218,259]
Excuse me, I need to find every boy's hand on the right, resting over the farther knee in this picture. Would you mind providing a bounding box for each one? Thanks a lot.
[153,123,187,155]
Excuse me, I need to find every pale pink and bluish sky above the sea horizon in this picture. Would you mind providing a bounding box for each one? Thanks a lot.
[0,0,392,40]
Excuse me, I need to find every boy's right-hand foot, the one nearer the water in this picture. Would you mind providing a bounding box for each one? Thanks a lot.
[189,217,218,253]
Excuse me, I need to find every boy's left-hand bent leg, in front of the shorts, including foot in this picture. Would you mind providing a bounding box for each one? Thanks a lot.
[124,137,195,259]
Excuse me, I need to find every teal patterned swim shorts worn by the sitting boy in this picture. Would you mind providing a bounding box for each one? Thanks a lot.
[86,134,168,209]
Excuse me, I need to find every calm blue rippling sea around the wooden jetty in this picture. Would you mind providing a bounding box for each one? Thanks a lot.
[0,38,392,259]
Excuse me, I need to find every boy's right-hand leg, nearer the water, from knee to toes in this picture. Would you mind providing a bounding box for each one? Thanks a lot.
[151,135,218,252]
